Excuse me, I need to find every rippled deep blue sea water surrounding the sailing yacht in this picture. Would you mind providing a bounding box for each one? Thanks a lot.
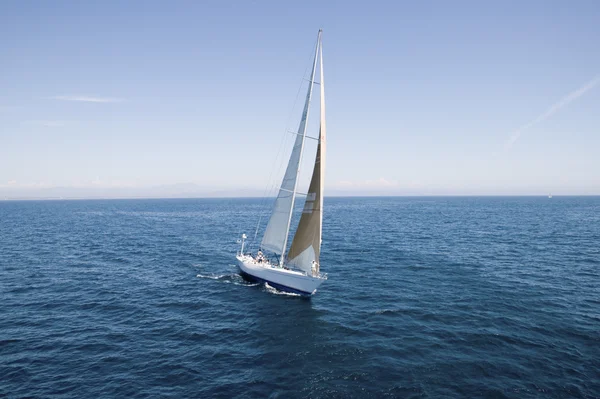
[0,197,600,398]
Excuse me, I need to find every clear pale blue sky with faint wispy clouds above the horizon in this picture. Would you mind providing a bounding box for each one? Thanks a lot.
[0,0,600,198]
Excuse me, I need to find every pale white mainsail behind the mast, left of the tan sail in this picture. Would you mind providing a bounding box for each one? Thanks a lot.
[261,34,320,255]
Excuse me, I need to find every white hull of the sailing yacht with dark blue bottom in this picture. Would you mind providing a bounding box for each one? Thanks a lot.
[236,255,327,295]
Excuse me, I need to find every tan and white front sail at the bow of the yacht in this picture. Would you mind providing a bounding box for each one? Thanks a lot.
[288,32,327,274]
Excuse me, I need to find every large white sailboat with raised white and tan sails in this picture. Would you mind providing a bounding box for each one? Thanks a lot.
[236,30,327,295]
